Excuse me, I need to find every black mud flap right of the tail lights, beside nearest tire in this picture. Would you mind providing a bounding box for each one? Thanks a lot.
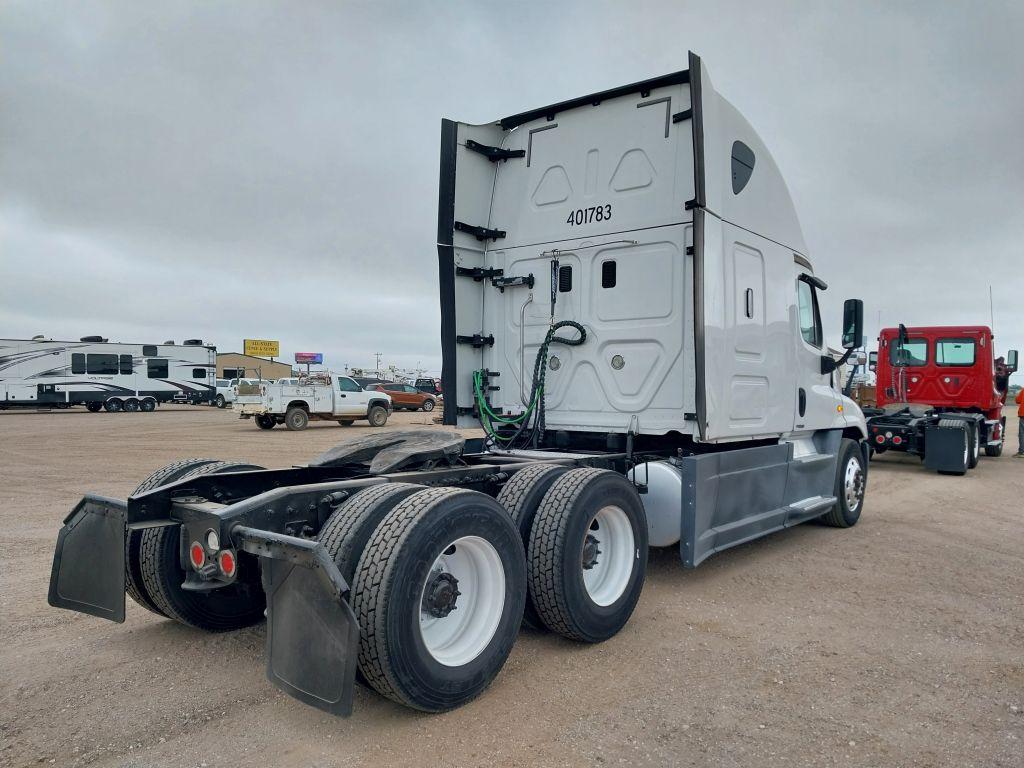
[262,556,359,717]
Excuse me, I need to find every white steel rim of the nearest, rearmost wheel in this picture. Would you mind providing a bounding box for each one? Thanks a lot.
[420,536,505,667]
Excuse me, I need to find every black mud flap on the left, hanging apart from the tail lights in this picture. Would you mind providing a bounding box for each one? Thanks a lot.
[48,496,128,623]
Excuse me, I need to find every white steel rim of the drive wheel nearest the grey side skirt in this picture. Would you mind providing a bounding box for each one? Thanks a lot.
[580,505,636,605]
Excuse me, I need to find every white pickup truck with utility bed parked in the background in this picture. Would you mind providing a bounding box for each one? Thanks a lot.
[234,373,392,430]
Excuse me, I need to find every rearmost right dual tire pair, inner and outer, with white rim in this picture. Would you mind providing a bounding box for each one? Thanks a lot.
[321,484,526,712]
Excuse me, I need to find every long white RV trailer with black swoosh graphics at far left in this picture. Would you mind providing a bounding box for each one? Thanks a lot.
[0,337,216,412]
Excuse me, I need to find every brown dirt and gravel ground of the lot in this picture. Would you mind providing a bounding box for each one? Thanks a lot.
[0,407,1024,768]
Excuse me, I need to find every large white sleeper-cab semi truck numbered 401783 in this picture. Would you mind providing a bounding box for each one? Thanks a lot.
[49,54,867,714]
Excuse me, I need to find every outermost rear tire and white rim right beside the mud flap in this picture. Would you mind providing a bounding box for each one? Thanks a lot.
[351,488,526,712]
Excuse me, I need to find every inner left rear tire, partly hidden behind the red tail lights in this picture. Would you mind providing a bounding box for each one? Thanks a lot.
[139,462,266,632]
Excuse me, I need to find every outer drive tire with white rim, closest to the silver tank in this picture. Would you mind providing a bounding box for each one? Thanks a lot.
[526,468,647,643]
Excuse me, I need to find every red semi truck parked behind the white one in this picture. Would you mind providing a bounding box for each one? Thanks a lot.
[864,325,1017,475]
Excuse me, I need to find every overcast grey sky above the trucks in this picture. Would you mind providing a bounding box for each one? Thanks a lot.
[0,0,1024,381]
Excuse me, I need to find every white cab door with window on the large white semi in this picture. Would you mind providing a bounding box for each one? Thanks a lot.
[793,263,839,432]
